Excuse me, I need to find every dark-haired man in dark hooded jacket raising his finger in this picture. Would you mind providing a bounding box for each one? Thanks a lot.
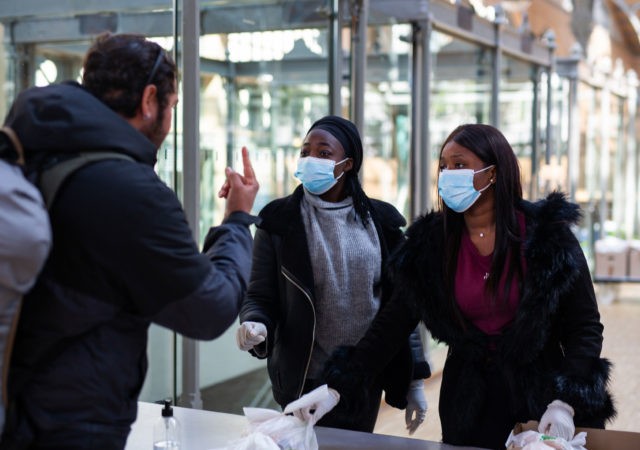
[0,34,258,450]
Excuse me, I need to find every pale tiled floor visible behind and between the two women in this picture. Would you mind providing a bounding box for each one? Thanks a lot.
[375,283,640,441]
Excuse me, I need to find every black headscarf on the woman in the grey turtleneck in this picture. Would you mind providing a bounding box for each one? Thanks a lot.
[307,116,369,226]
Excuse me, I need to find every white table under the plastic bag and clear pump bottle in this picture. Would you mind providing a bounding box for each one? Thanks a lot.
[125,402,478,450]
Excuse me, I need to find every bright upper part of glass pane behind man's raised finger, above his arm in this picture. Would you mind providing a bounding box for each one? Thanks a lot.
[200,23,328,232]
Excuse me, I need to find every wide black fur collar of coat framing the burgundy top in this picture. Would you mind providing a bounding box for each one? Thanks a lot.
[391,193,584,360]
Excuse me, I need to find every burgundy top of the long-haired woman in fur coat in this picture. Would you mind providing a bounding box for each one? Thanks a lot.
[455,213,525,336]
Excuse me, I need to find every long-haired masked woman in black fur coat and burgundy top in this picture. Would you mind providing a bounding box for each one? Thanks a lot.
[325,124,615,449]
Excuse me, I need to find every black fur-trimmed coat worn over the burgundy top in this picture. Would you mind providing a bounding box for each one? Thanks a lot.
[326,193,615,437]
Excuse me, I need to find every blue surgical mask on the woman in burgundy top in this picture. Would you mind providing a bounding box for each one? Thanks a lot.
[438,165,493,212]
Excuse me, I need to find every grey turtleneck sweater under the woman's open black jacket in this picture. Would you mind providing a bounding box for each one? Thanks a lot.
[301,190,382,378]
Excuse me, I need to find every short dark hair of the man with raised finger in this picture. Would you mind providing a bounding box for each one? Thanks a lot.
[82,33,176,117]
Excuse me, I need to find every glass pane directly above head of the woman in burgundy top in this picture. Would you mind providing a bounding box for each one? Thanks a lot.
[430,31,493,199]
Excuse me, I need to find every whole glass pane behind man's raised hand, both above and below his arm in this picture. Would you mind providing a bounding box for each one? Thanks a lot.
[199,13,329,414]
